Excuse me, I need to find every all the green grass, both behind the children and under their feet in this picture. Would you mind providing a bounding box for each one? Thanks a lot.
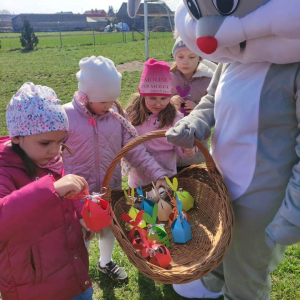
[0,36,300,300]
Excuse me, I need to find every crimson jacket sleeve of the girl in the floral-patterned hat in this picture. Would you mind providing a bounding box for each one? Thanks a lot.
[0,172,61,239]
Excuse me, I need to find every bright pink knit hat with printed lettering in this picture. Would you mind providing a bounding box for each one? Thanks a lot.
[139,58,172,97]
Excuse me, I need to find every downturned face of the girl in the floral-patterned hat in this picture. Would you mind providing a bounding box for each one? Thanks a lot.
[12,130,67,165]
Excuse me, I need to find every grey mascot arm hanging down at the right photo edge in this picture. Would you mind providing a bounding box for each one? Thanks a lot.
[266,72,300,247]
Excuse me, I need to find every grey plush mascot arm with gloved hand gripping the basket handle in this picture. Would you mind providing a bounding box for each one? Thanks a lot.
[166,64,224,148]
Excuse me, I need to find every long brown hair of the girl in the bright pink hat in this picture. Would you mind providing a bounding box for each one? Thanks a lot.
[125,93,176,129]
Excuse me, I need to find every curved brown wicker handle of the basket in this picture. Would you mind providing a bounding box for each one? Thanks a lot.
[102,130,216,200]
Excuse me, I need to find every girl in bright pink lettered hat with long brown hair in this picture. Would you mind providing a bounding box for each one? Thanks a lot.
[126,58,195,186]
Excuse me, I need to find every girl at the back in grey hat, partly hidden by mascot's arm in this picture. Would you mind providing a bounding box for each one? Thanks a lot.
[171,37,216,172]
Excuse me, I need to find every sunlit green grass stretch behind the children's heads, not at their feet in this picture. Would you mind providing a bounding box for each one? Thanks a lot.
[0,38,173,135]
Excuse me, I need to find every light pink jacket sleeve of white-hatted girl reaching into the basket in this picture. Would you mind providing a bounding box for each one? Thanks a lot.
[122,120,168,181]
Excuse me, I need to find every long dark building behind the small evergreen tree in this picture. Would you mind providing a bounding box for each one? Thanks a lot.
[12,14,88,32]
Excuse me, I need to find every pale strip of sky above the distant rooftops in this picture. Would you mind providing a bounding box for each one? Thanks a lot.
[0,0,131,14]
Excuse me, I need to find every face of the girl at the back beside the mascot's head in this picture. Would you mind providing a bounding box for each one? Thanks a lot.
[175,48,200,77]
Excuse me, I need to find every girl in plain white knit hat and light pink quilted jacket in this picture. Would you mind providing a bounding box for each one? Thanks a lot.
[63,56,168,281]
